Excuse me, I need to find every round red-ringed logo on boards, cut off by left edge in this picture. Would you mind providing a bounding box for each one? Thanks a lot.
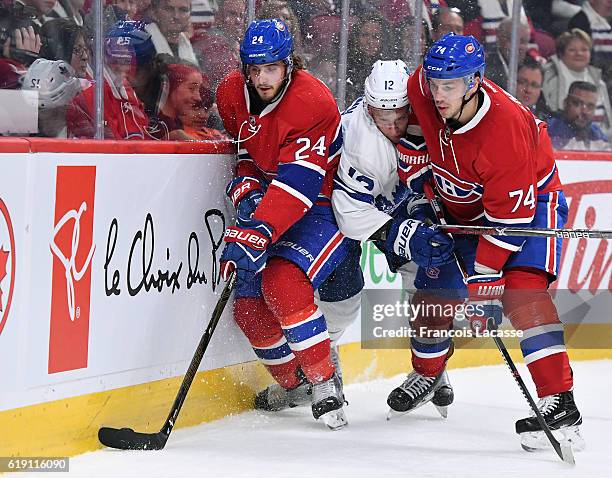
[0,198,15,334]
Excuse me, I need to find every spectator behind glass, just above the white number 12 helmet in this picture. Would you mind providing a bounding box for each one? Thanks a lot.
[346,13,392,105]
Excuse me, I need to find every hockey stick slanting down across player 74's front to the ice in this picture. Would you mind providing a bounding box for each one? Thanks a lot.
[423,183,576,465]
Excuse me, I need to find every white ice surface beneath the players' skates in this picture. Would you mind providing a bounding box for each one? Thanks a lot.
[44,361,612,478]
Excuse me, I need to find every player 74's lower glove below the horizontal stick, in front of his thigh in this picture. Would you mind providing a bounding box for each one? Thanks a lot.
[465,272,506,332]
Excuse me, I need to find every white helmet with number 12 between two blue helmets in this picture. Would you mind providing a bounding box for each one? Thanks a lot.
[365,60,410,110]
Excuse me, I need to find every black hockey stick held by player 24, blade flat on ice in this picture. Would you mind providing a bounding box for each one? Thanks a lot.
[98,272,236,450]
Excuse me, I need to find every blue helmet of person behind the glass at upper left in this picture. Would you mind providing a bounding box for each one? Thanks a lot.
[104,20,155,66]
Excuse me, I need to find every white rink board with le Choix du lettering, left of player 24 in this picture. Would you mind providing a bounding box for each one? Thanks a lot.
[0,153,260,410]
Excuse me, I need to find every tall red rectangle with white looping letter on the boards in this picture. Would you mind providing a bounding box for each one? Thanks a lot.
[49,166,96,373]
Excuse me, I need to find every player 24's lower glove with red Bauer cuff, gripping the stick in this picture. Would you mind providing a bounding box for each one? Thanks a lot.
[220,217,272,282]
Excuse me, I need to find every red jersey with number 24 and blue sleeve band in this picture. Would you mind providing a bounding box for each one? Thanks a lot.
[217,70,341,241]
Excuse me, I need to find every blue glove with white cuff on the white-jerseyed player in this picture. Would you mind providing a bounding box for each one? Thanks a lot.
[385,219,454,267]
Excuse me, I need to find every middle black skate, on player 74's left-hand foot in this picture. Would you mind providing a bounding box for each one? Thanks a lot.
[387,370,454,420]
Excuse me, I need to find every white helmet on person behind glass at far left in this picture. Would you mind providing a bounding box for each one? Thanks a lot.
[22,58,92,110]
